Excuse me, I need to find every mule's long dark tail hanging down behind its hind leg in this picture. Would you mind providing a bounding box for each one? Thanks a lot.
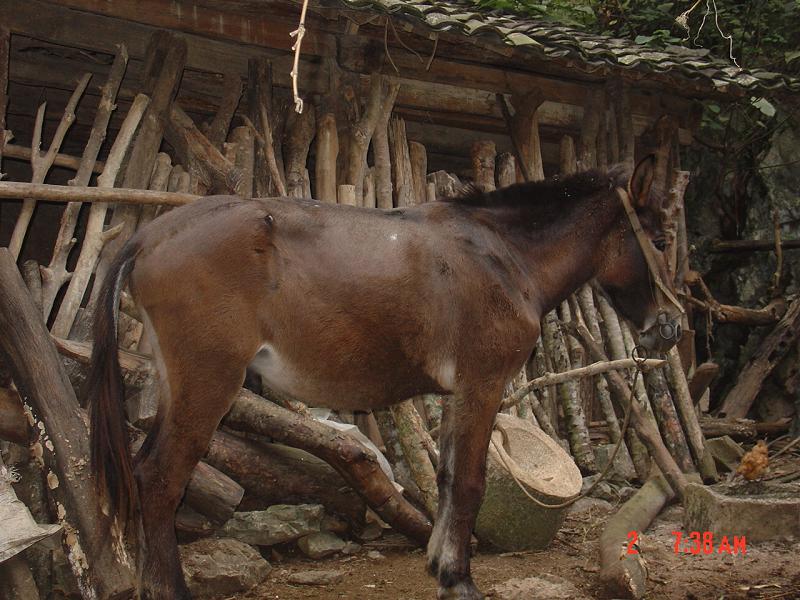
[87,242,139,530]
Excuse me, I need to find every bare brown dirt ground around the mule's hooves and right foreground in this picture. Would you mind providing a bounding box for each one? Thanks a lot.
[236,502,800,600]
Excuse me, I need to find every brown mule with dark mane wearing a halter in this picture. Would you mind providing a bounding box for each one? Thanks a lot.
[90,158,678,600]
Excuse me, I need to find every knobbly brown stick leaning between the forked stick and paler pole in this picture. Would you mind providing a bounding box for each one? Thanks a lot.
[42,45,128,320]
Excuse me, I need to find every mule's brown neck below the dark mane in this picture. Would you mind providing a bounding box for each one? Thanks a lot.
[494,193,624,315]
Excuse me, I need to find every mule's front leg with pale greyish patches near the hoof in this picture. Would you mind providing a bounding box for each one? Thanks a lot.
[428,393,500,600]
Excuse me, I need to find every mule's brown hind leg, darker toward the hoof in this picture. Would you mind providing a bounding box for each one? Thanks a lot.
[134,354,244,600]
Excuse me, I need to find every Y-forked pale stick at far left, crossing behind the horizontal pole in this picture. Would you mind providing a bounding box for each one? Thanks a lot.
[8,73,92,258]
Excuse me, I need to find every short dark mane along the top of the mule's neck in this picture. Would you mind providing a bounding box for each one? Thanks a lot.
[442,165,624,213]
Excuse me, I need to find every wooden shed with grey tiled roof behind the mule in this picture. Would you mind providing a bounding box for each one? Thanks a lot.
[0,0,797,596]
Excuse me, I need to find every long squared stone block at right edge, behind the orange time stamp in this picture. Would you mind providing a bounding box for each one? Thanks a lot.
[684,482,800,544]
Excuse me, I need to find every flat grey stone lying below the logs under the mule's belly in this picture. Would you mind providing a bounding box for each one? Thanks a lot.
[220,504,325,546]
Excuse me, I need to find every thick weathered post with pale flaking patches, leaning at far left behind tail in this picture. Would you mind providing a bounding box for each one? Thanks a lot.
[0,248,134,598]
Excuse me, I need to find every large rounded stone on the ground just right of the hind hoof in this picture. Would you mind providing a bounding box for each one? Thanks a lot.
[180,538,272,598]
